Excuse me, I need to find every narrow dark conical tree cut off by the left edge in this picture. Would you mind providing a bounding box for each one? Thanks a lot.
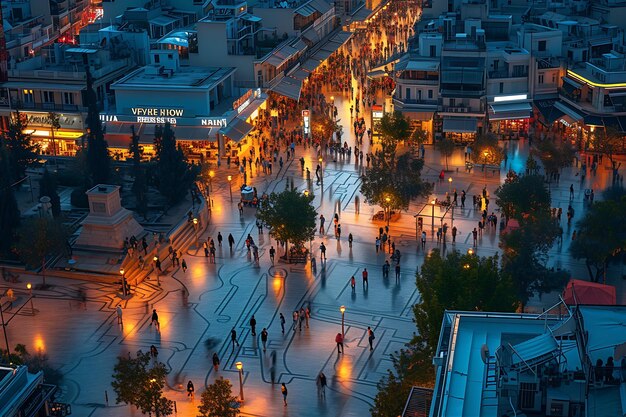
[0,141,20,256]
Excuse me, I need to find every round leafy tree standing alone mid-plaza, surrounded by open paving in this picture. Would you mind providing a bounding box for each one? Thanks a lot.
[256,189,317,252]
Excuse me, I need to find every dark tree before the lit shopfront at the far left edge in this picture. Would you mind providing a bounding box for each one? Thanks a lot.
[1,111,39,182]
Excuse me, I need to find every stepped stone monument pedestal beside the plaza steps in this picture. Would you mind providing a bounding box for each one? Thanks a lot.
[76,184,143,249]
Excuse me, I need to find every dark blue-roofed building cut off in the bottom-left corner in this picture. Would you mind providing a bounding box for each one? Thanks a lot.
[0,366,61,417]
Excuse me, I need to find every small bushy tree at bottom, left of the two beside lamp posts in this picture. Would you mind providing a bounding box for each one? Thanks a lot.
[111,350,174,417]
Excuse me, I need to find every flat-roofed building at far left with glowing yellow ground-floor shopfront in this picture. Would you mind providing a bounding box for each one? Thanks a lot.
[0,43,134,156]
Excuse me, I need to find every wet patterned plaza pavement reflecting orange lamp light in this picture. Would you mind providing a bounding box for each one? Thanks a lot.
[1,92,624,417]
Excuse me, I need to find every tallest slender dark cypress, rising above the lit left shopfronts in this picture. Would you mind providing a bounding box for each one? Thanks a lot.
[85,66,111,187]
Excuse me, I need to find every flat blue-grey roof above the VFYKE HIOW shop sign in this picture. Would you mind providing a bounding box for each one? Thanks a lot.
[111,66,236,90]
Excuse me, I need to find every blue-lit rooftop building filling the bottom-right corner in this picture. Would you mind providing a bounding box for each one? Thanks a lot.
[416,305,626,417]
